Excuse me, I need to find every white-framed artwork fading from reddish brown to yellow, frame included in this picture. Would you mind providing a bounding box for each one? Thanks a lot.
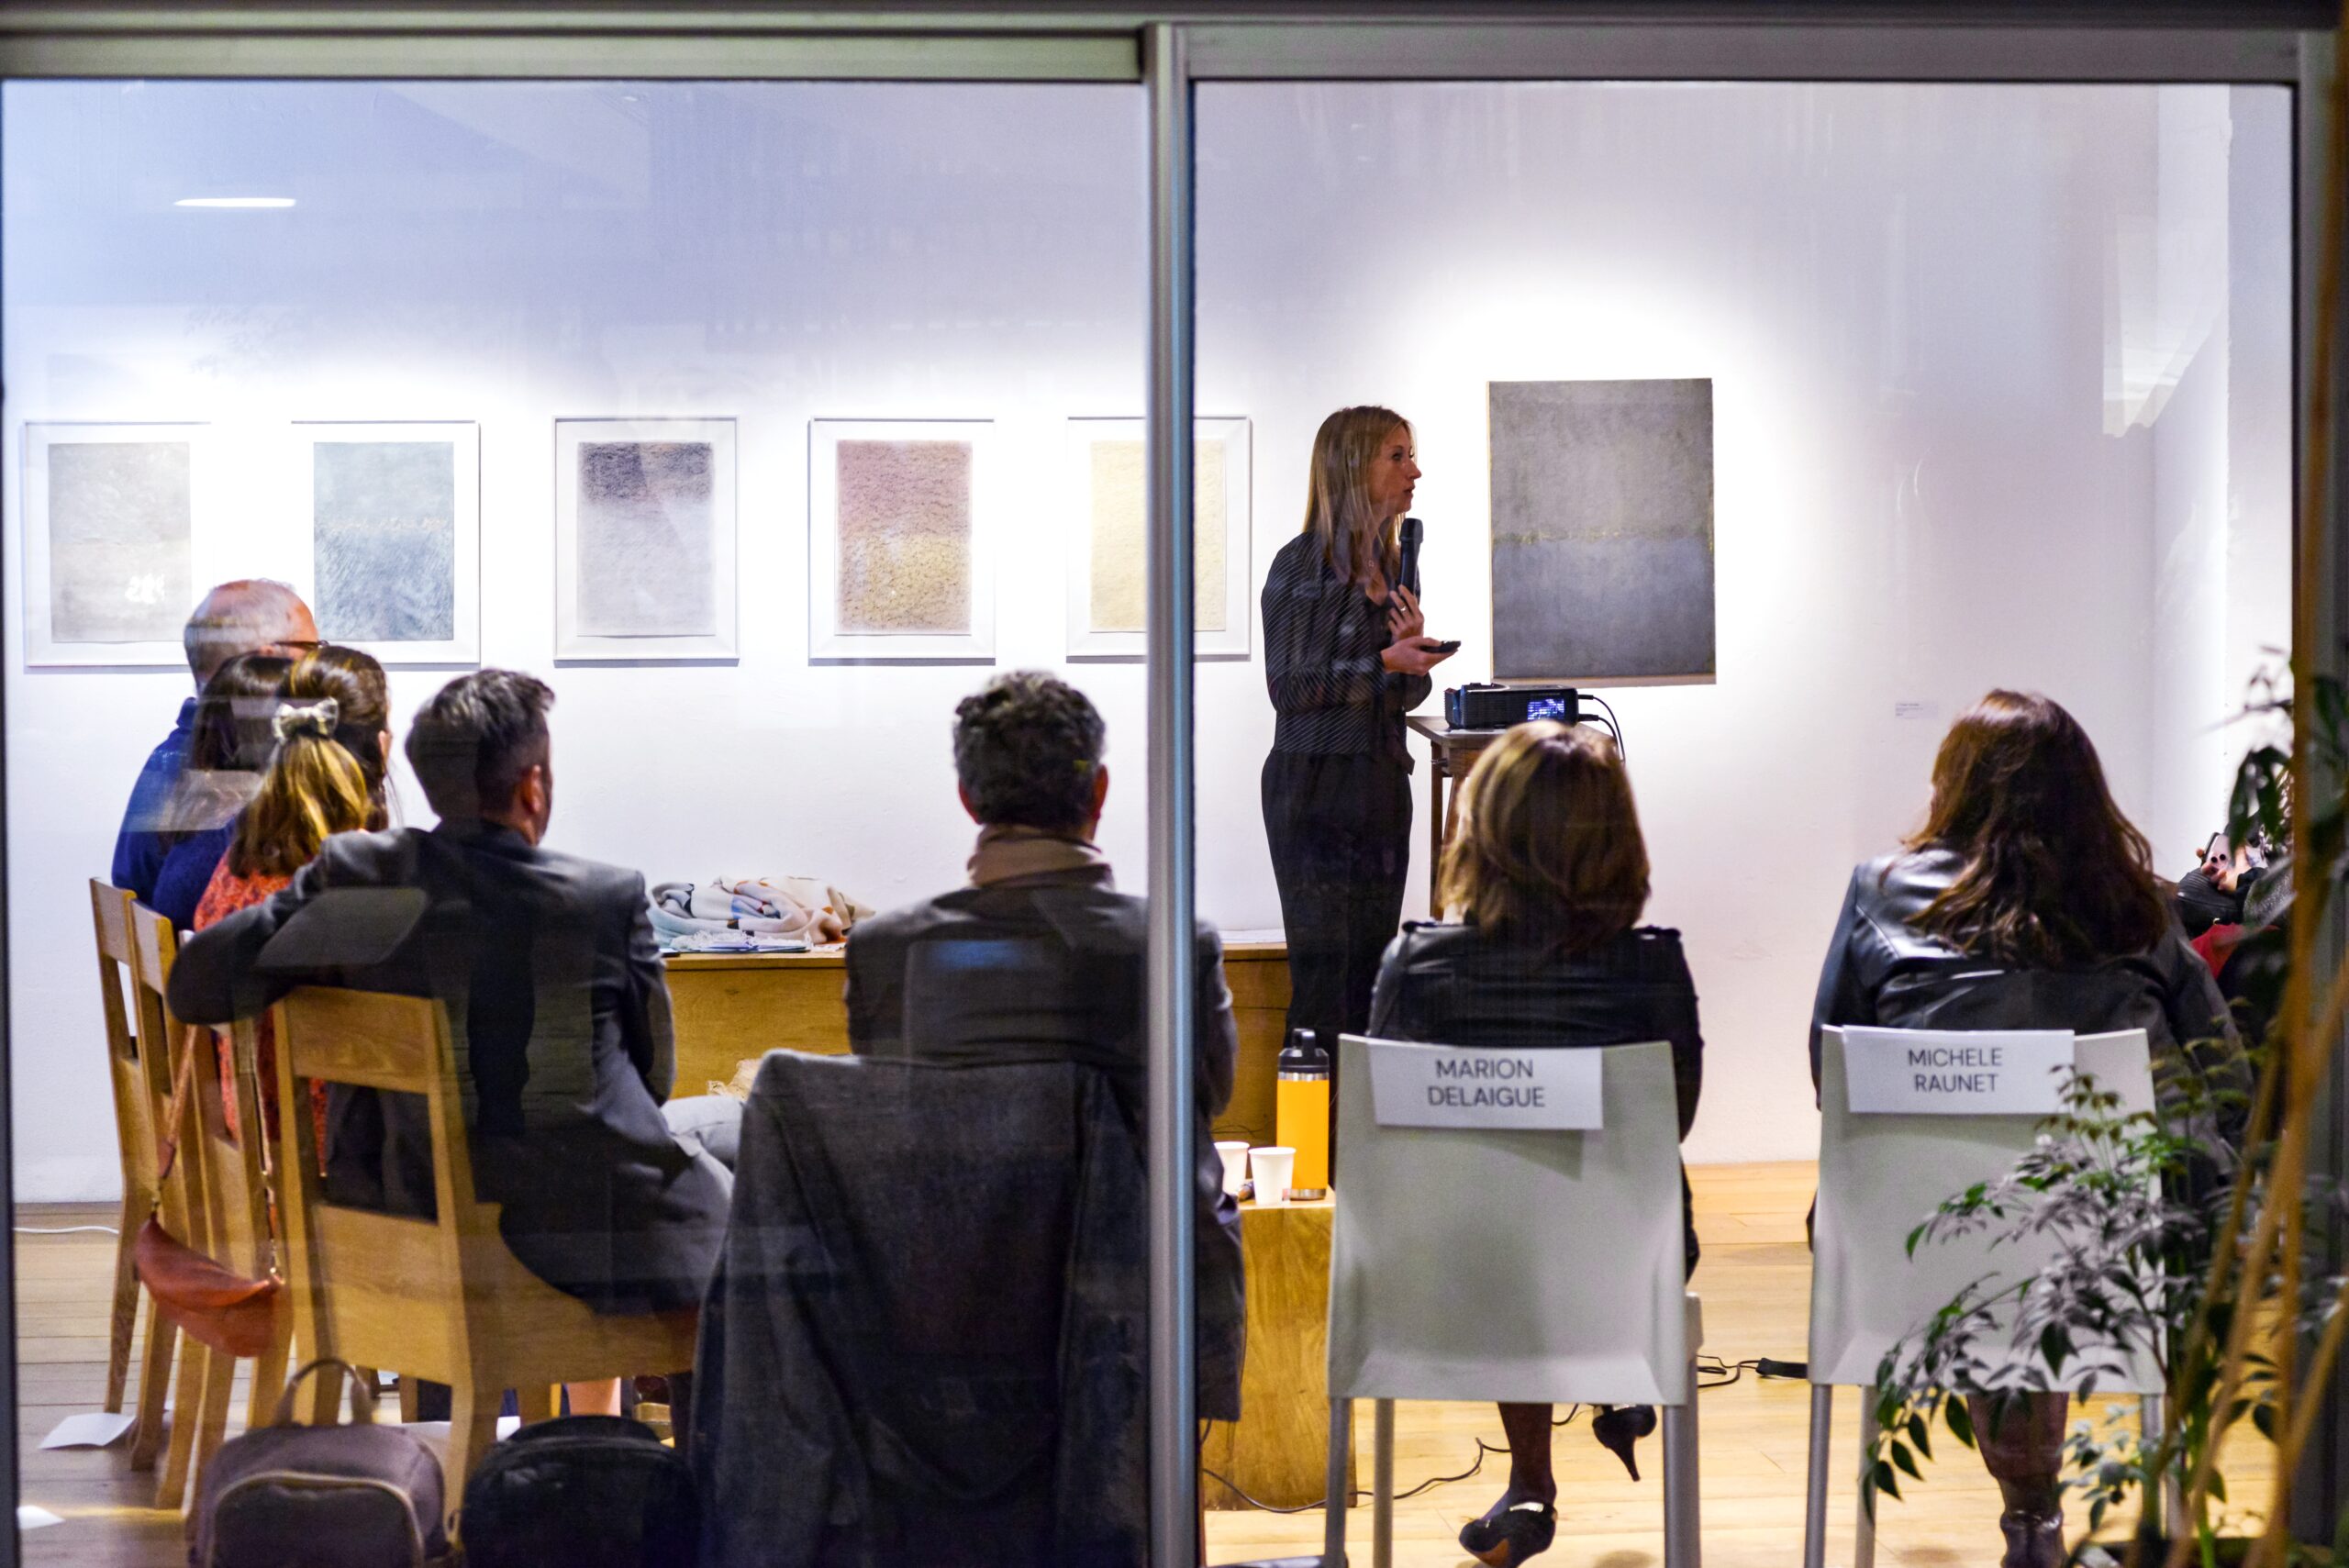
[808,420,996,664]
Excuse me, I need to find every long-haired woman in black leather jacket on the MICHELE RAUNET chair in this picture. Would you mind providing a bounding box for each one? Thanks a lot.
[1811,690,2248,1568]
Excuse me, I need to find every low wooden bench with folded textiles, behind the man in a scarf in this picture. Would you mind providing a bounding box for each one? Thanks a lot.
[667,941,1289,1143]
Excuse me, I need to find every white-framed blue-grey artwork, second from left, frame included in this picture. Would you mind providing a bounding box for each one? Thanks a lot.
[294,423,482,664]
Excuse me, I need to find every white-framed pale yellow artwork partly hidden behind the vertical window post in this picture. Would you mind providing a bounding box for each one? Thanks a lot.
[1069,417,1252,660]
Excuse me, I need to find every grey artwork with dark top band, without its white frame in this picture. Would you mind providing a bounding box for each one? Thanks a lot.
[578,441,718,636]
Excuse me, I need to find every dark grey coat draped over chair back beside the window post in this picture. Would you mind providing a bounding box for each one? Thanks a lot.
[691,1051,1149,1568]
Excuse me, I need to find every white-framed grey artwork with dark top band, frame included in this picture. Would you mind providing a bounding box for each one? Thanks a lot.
[554,417,735,662]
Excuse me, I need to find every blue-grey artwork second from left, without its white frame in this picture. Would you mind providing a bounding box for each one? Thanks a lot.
[310,441,456,643]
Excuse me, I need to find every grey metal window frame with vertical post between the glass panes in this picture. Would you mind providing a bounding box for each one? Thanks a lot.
[0,12,2349,1565]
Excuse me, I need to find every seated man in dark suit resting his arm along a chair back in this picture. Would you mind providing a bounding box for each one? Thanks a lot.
[172,669,730,1333]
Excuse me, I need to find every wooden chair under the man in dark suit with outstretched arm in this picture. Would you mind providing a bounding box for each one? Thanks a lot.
[275,988,700,1509]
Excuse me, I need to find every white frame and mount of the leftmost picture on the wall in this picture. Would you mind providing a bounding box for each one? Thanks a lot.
[21,420,214,669]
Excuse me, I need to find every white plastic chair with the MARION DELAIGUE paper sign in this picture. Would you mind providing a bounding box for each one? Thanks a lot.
[1322,1035,1703,1568]
